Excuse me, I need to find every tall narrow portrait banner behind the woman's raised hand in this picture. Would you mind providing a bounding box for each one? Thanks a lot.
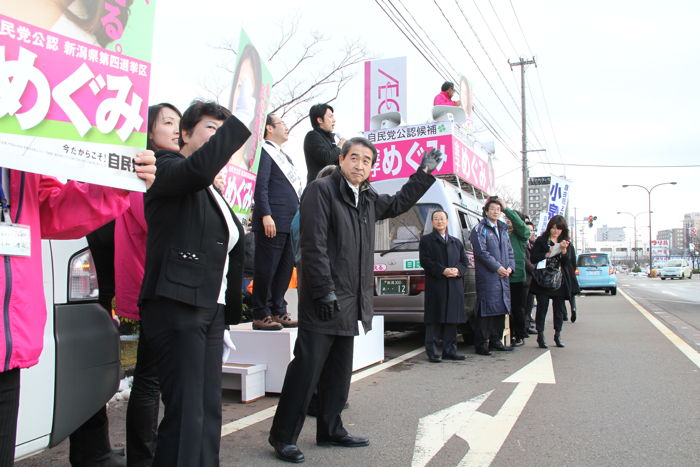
[221,30,272,215]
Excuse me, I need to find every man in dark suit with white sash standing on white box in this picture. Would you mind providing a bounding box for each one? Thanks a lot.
[251,114,301,331]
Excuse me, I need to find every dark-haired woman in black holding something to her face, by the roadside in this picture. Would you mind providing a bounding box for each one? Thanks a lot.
[530,216,579,349]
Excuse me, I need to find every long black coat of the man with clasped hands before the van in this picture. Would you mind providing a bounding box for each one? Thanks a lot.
[418,231,469,324]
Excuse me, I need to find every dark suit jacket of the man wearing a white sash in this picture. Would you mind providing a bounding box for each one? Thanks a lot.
[252,145,299,233]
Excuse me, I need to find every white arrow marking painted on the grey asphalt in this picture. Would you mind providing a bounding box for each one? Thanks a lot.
[411,352,556,467]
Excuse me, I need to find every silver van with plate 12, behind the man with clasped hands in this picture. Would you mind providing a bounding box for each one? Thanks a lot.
[372,175,486,338]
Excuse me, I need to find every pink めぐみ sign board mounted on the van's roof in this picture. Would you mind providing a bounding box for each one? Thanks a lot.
[365,122,494,193]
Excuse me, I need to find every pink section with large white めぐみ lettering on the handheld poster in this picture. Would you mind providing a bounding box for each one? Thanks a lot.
[0,15,150,142]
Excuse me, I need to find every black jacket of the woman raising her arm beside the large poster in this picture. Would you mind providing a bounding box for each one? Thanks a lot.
[139,117,250,324]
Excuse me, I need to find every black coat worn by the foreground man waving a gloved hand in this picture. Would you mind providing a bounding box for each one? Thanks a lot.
[299,169,435,336]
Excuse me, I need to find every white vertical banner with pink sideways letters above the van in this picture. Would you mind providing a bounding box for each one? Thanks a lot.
[365,57,408,131]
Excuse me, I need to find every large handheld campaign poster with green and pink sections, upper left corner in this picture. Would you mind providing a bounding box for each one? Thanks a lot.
[0,0,156,191]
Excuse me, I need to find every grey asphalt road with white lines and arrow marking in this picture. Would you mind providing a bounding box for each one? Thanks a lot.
[17,276,700,467]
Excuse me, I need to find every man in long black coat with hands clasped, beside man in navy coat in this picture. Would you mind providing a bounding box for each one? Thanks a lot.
[419,209,469,363]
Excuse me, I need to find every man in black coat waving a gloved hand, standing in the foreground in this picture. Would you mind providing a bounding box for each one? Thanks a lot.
[269,138,442,462]
